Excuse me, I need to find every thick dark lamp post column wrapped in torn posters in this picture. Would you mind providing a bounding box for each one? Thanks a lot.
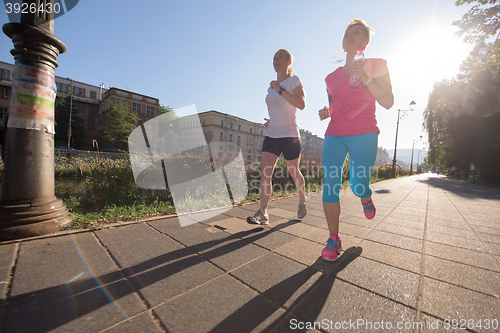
[0,0,72,241]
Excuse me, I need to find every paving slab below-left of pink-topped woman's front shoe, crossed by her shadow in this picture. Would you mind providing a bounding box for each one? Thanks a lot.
[231,253,322,309]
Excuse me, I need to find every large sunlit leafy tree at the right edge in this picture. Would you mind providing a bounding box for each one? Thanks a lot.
[424,0,500,184]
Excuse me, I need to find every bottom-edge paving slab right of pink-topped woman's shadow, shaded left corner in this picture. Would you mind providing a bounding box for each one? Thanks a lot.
[293,274,416,332]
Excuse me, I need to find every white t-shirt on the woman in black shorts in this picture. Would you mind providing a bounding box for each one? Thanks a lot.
[266,76,302,138]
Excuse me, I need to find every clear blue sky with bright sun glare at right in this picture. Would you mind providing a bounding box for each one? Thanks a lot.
[0,0,472,150]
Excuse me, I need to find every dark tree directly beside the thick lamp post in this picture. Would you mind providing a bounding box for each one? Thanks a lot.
[54,95,85,148]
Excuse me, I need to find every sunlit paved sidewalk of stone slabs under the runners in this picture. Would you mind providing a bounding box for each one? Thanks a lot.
[0,174,500,333]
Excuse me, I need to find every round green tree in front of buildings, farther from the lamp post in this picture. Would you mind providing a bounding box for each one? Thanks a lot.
[98,101,140,150]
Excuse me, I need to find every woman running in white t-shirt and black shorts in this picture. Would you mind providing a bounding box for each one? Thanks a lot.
[247,49,307,225]
